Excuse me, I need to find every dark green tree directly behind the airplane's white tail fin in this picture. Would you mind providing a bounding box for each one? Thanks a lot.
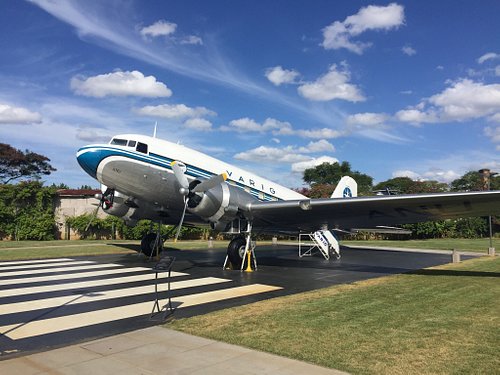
[303,161,373,195]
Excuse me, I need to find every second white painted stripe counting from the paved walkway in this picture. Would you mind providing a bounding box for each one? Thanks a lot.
[0,277,231,315]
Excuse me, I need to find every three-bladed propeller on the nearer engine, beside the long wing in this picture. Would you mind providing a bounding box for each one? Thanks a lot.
[170,160,227,242]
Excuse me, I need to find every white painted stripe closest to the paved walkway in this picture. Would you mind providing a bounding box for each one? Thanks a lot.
[0,284,281,340]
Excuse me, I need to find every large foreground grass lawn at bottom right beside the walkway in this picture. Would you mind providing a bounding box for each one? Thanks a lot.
[166,257,500,374]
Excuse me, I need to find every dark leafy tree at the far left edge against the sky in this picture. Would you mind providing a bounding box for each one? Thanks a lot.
[0,143,56,184]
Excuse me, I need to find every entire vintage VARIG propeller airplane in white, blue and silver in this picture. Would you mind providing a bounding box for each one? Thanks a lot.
[77,134,500,269]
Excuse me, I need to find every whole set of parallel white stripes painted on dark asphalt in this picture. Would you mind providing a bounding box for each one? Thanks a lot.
[0,258,281,340]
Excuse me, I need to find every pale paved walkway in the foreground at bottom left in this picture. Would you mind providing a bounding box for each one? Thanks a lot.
[0,327,345,375]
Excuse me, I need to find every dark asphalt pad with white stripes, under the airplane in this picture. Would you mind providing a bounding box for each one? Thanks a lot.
[0,242,470,359]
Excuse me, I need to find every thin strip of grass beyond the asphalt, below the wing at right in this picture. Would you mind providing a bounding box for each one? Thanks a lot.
[341,238,500,254]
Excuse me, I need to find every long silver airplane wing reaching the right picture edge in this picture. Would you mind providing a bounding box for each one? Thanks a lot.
[248,191,500,231]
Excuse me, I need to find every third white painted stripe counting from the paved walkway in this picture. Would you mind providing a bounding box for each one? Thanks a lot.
[0,272,187,297]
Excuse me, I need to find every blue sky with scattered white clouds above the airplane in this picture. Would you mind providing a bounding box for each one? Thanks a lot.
[0,0,500,187]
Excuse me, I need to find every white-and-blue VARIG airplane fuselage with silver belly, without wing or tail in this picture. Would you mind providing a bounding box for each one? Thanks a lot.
[77,134,305,229]
